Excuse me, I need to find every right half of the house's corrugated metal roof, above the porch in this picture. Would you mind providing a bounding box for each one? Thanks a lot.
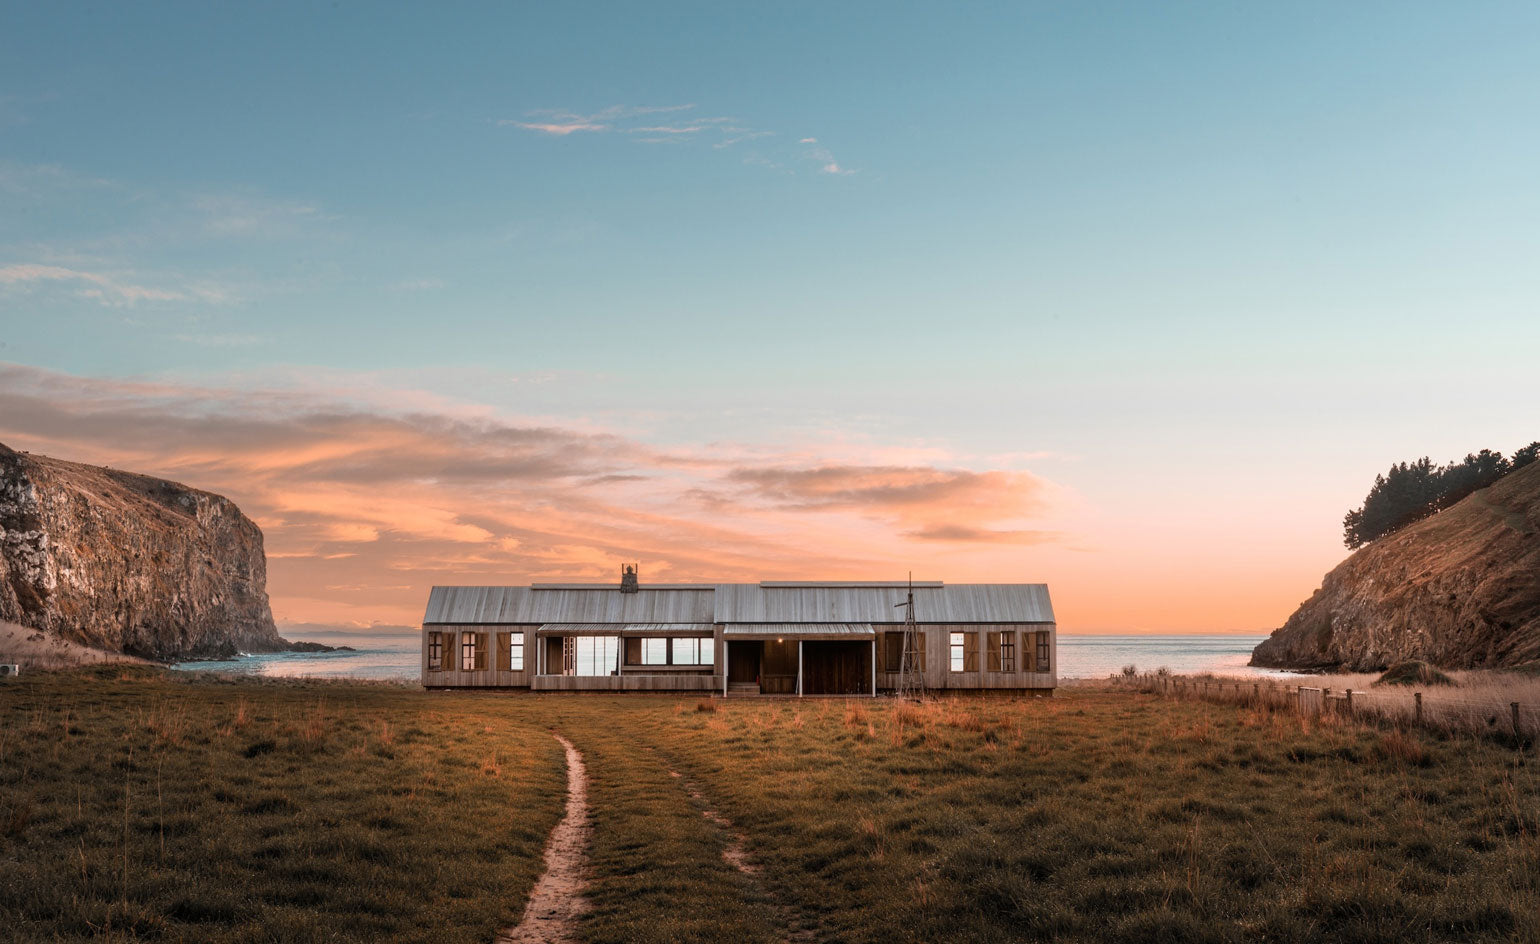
[716,584,1053,622]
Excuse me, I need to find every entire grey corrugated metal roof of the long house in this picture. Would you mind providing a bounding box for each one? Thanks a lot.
[422,584,1053,624]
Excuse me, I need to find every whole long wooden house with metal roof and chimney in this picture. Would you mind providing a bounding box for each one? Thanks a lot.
[422,568,1058,695]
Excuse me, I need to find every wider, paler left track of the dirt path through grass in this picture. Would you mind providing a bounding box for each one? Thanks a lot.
[493,735,593,944]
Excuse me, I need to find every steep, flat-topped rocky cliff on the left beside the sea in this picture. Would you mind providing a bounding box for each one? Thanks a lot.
[0,445,288,659]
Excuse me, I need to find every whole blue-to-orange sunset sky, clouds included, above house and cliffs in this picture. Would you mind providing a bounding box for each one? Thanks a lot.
[0,0,1540,631]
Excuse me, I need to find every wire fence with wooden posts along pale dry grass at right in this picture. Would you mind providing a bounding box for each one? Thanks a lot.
[1112,675,1540,744]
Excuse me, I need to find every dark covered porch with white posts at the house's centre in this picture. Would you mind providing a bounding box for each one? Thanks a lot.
[722,622,876,696]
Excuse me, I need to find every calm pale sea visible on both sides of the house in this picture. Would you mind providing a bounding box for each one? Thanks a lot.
[168,633,1287,682]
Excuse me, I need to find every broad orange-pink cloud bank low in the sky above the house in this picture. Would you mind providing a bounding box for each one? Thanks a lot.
[0,365,1056,624]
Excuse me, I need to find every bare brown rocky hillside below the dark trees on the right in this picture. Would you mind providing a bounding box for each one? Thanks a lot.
[1252,462,1540,671]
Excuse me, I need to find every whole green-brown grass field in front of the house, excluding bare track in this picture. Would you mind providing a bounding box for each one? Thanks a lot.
[0,668,1540,944]
